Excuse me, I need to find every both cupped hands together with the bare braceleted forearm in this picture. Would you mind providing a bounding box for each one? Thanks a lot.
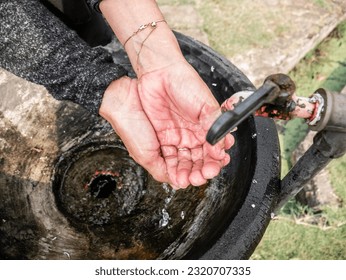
[100,0,234,189]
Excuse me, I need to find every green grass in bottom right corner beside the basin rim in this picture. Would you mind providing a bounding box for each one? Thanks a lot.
[251,219,346,260]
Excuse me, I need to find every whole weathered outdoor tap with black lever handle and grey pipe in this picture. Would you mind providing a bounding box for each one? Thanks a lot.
[207,74,346,209]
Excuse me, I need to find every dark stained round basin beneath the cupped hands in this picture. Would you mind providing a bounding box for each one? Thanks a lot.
[0,33,280,259]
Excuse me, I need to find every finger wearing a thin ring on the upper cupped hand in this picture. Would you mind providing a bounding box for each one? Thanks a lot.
[177,148,193,188]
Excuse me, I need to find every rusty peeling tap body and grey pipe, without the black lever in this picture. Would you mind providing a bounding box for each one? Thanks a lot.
[216,74,346,210]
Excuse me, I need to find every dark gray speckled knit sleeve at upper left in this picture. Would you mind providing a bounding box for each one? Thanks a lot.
[0,0,126,114]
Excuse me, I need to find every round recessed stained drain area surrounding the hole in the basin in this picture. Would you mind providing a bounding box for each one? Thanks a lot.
[53,143,147,225]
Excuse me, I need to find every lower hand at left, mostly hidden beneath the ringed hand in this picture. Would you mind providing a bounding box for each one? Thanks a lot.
[99,77,170,183]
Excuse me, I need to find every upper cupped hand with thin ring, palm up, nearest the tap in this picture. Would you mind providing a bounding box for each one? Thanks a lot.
[138,60,234,188]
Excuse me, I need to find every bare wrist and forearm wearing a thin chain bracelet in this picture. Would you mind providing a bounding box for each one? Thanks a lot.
[100,0,183,77]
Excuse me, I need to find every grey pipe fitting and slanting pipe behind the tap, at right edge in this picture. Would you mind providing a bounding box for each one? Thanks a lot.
[276,89,346,210]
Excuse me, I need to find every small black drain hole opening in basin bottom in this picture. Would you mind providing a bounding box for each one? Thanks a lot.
[89,174,117,198]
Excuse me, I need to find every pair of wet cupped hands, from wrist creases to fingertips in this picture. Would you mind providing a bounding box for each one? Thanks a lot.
[100,63,234,189]
